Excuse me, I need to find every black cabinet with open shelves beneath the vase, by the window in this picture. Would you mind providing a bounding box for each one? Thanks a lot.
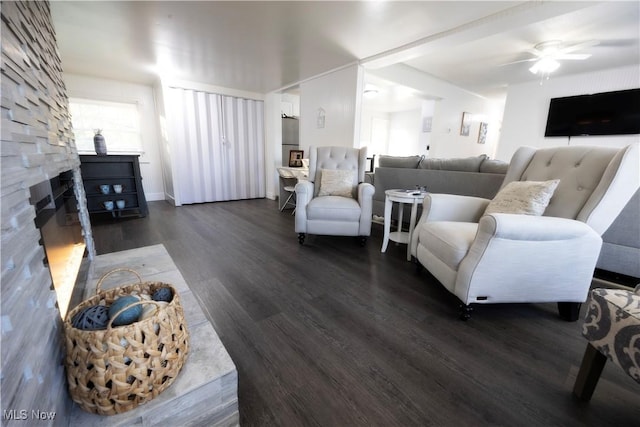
[80,155,148,217]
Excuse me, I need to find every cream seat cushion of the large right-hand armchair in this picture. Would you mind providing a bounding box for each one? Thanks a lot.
[419,221,478,271]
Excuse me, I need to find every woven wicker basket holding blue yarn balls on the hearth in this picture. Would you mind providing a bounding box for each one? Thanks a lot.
[64,268,189,415]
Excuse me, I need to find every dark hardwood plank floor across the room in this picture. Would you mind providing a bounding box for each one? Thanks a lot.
[93,199,640,426]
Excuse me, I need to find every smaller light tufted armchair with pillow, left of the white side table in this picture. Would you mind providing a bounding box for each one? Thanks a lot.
[295,147,374,245]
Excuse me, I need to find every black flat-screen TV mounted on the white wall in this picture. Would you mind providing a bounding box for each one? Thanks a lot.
[544,89,640,136]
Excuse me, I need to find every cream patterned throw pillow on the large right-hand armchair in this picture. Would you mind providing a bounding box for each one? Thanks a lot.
[484,179,560,216]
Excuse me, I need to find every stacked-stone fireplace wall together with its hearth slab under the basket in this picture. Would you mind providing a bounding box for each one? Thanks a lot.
[0,2,238,426]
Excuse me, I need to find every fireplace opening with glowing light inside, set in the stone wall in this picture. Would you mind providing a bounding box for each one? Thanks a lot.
[29,170,86,319]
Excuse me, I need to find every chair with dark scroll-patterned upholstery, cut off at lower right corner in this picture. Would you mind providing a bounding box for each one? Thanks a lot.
[573,285,640,401]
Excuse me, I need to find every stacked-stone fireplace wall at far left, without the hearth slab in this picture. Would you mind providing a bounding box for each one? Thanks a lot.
[0,2,95,426]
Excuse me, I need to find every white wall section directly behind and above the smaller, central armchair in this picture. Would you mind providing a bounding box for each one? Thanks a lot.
[300,65,362,157]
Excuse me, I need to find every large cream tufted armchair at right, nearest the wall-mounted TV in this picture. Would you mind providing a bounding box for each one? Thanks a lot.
[411,143,640,321]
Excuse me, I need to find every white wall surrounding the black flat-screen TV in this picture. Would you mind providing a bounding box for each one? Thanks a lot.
[496,66,640,161]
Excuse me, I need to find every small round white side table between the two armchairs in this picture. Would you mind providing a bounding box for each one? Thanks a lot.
[381,190,426,261]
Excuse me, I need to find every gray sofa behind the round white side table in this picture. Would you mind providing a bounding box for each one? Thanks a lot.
[367,155,508,219]
